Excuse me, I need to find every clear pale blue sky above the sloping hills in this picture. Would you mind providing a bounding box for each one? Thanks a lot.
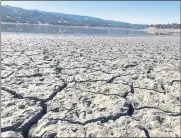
[1,1,180,24]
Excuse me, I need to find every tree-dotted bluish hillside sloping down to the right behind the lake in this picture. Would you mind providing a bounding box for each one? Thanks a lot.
[1,6,149,29]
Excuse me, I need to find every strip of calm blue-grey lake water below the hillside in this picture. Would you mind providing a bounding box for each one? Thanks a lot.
[1,24,147,35]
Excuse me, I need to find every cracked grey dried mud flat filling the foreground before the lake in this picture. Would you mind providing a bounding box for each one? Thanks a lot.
[1,34,181,138]
